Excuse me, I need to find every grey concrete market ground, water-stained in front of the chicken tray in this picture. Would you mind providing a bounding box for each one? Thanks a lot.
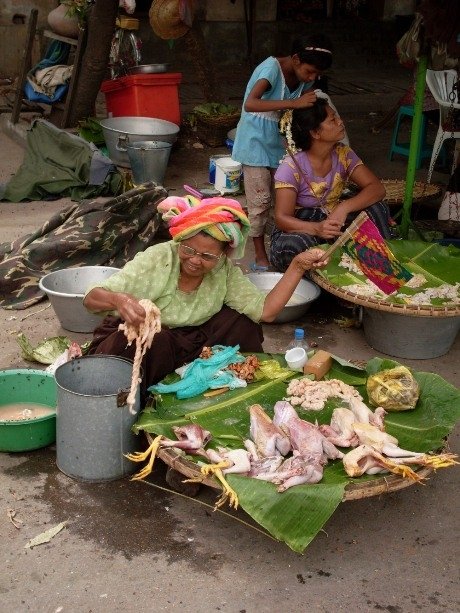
[0,52,460,613]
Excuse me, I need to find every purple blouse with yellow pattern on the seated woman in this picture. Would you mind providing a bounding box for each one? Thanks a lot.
[275,143,363,211]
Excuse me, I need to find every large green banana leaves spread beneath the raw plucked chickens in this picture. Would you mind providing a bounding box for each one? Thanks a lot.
[133,355,460,553]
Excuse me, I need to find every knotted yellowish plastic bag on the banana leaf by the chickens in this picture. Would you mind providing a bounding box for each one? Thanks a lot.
[367,366,420,411]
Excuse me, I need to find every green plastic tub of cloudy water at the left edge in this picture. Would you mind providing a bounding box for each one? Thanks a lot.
[0,369,57,451]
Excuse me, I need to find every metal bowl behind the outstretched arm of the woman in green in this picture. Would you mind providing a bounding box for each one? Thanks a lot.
[246,272,321,324]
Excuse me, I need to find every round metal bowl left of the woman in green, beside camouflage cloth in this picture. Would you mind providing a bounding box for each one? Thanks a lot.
[39,266,120,332]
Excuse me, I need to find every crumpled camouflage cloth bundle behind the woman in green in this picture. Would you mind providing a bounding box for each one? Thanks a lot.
[0,182,166,309]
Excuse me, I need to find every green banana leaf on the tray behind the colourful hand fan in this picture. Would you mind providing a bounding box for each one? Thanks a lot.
[317,240,460,306]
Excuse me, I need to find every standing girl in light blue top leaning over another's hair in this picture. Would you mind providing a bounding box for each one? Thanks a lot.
[232,34,332,270]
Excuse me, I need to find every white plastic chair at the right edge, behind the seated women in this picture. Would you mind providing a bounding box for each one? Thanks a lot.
[426,70,460,183]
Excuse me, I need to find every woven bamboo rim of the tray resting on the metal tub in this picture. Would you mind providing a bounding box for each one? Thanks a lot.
[310,270,460,317]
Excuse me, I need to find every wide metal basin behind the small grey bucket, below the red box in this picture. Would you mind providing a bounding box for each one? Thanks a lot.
[100,117,179,168]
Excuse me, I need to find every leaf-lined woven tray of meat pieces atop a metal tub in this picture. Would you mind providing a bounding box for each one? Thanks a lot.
[312,240,460,359]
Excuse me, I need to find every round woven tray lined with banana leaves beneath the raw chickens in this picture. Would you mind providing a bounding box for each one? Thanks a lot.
[130,354,460,552]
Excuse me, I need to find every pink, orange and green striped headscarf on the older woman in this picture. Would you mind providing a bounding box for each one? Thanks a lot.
[158,196,249,258]
